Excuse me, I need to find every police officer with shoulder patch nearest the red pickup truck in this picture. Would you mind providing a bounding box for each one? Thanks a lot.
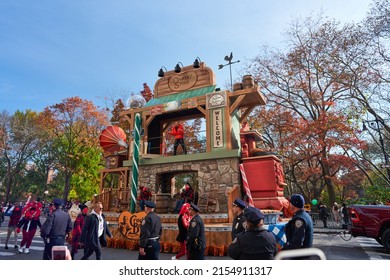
[283,194,313,250]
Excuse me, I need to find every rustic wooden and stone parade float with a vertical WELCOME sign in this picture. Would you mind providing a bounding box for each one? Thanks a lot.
[94,60,288,256]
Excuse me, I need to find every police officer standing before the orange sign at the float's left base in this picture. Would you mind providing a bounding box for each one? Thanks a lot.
[138,200,162,260]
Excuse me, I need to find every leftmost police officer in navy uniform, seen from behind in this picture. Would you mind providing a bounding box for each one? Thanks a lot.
[41,198,72,260]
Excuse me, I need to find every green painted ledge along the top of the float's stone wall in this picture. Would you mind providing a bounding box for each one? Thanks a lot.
[123,149,241,167]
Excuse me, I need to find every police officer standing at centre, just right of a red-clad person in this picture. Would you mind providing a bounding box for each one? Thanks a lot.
[187,202,206,260]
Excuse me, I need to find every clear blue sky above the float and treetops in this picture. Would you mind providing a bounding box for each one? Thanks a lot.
[0,0,372,113]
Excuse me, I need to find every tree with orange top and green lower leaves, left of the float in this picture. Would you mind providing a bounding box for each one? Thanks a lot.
[39,97,108,200]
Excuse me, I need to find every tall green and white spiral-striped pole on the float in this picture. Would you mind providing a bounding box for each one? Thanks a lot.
[130,113,141,213]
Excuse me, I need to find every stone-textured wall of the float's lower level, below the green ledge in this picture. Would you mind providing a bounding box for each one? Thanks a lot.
[138,157,241,213]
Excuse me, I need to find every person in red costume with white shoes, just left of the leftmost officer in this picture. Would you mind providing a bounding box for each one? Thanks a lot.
[16,207,41,254]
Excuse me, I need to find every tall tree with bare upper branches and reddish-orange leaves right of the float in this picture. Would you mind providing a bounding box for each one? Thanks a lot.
[250,16,361,203]
